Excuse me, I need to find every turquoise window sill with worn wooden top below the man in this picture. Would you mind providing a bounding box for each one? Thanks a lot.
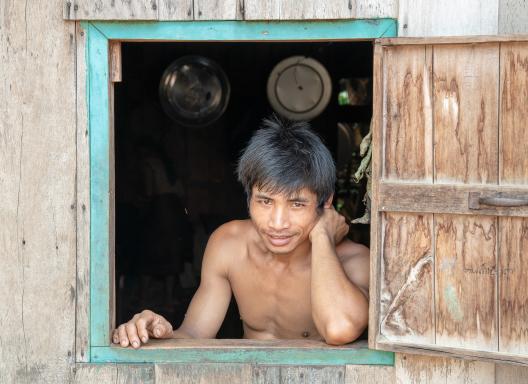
[91,339,394,365]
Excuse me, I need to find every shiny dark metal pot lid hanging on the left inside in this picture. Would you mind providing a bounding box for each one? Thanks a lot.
[159,55,231,127]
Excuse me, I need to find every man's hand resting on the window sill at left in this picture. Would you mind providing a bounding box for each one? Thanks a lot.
[112,309,172,348]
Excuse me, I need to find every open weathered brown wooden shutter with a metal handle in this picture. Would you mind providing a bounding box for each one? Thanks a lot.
[369,37,528,364]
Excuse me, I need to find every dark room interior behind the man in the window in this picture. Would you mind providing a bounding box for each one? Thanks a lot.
[114,42,373,338]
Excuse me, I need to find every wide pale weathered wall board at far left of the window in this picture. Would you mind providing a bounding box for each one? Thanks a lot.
[0,0,76,383]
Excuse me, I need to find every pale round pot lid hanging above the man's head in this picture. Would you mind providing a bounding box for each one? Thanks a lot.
[267,56,332,120]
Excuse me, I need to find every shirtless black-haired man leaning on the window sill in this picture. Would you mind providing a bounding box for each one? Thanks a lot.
[112,119,369,348]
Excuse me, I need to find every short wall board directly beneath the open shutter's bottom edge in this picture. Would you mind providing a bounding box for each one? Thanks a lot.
[394,353,499,384]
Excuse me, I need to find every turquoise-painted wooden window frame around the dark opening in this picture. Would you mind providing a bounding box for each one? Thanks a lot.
[86,20,395,364]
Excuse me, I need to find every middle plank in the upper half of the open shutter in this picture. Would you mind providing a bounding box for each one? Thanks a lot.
[433,43,499,184]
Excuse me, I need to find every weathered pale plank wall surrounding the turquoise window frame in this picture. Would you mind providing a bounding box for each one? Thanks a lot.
[0,0,528,384]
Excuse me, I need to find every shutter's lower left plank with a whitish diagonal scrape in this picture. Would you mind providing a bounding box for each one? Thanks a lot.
[380,213,435,344]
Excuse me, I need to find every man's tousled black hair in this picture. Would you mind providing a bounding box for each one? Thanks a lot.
[237,115,336,208]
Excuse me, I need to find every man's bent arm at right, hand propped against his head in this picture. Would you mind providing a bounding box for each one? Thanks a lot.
[310,207,369,345]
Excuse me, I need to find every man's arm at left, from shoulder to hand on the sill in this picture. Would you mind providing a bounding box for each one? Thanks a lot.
[112,225,233,348]
